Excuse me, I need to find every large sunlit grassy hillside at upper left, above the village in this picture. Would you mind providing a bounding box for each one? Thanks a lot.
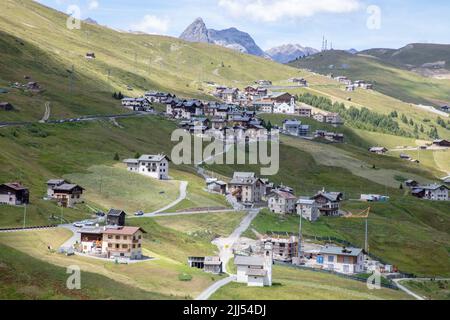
[0,0,296,120]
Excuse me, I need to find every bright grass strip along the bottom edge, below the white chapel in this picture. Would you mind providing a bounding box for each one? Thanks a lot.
[211,266,409,300]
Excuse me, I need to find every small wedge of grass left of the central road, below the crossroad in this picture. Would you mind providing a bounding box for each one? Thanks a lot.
[154,212,245,241]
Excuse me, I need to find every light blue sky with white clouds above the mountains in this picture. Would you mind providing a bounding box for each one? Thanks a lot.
[38,0,450,50]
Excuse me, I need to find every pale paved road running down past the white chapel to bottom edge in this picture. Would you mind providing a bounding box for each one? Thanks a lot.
[195,209,259,300]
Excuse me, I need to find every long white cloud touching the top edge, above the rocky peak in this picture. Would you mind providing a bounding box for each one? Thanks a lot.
[219,0,361,22]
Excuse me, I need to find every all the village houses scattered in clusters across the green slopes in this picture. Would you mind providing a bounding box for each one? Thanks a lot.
[0,77,450,286]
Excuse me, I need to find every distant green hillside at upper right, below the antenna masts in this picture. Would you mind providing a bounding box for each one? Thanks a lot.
[289,50,450,106]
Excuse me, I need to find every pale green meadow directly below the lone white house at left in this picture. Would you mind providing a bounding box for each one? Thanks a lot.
[64,165,179,214]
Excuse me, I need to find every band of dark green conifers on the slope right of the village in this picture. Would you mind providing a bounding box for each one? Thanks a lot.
[297,93,412,137]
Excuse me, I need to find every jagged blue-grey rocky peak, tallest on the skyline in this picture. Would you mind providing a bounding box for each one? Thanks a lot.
[180,18,266,57]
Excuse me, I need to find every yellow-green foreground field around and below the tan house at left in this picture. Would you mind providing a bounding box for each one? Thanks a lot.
[0,219,220,299]
